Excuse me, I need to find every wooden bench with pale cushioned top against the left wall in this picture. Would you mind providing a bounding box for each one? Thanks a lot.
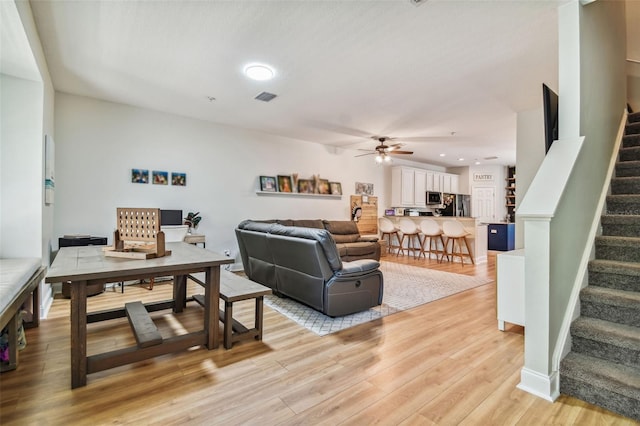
[0,258,46,372]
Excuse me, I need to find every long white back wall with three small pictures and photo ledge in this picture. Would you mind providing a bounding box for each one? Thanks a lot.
[54,93,387,261]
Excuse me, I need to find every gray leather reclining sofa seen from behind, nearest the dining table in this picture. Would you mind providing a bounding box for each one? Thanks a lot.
[236,220,383,317]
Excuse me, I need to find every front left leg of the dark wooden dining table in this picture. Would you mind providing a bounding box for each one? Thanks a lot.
[71,281,87,389]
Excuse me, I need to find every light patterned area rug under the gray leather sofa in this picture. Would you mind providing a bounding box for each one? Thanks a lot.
[264,261,490,336]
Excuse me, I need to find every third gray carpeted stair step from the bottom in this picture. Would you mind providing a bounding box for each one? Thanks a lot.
[580,285,640,327]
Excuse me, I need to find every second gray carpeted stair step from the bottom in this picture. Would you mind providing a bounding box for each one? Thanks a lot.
[571,317,640,367]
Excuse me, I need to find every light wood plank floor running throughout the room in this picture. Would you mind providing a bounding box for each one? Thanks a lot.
[0,251,635,425]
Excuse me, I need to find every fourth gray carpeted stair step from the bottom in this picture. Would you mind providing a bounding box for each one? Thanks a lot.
[589,259,640,291]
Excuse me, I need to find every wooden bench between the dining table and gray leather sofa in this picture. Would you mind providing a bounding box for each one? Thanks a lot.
[189,271,271,349]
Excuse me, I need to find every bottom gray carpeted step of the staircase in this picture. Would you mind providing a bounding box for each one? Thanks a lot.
[560,352,640,421]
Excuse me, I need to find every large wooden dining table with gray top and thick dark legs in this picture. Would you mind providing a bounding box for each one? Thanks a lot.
[45,242,233,388]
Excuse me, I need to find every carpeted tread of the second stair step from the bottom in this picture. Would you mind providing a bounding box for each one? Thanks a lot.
[571,317,640,350]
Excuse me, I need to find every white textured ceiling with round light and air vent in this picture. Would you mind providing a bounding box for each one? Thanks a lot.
[26,0,563,166]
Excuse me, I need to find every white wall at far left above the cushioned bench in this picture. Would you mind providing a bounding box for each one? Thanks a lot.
[0,1,54,317]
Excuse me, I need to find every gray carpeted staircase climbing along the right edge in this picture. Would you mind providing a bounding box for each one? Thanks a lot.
[560,113,640,421]
